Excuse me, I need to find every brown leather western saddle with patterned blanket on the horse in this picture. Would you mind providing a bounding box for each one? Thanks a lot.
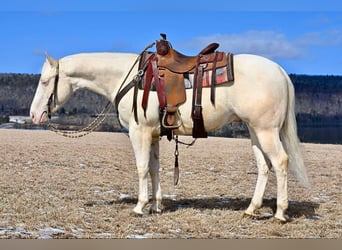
[139,34,234,139]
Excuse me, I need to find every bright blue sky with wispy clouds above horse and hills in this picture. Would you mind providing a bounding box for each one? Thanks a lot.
[0,0,342,75]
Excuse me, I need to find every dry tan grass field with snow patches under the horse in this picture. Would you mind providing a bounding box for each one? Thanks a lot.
[0,129,342,239]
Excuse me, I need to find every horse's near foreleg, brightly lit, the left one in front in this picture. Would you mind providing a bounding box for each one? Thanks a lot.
[129,126,152,214]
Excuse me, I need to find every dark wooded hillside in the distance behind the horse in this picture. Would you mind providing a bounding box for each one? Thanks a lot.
[0,74,342,143]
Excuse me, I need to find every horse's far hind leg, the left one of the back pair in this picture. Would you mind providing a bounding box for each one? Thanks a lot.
[245,128,270,216]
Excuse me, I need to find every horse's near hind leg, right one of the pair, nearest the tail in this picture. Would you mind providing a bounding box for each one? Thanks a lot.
[255,128,288,221]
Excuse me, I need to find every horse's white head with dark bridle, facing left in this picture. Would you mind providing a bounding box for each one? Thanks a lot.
[30,54,71,124]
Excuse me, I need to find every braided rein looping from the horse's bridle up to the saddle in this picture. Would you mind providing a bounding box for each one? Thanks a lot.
[47,42,155,138]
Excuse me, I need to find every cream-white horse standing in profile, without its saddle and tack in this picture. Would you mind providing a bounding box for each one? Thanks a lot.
[30,50,309,221]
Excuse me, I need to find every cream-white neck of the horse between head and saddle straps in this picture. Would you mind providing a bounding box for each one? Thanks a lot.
[62,53,137,101]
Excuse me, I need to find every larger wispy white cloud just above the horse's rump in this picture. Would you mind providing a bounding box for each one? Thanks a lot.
[184,30,302,59]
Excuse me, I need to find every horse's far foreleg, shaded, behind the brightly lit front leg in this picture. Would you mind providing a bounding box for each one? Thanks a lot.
[150,138,162,213]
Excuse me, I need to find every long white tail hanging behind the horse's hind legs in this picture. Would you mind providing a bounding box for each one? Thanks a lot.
[280,69,311,188]
